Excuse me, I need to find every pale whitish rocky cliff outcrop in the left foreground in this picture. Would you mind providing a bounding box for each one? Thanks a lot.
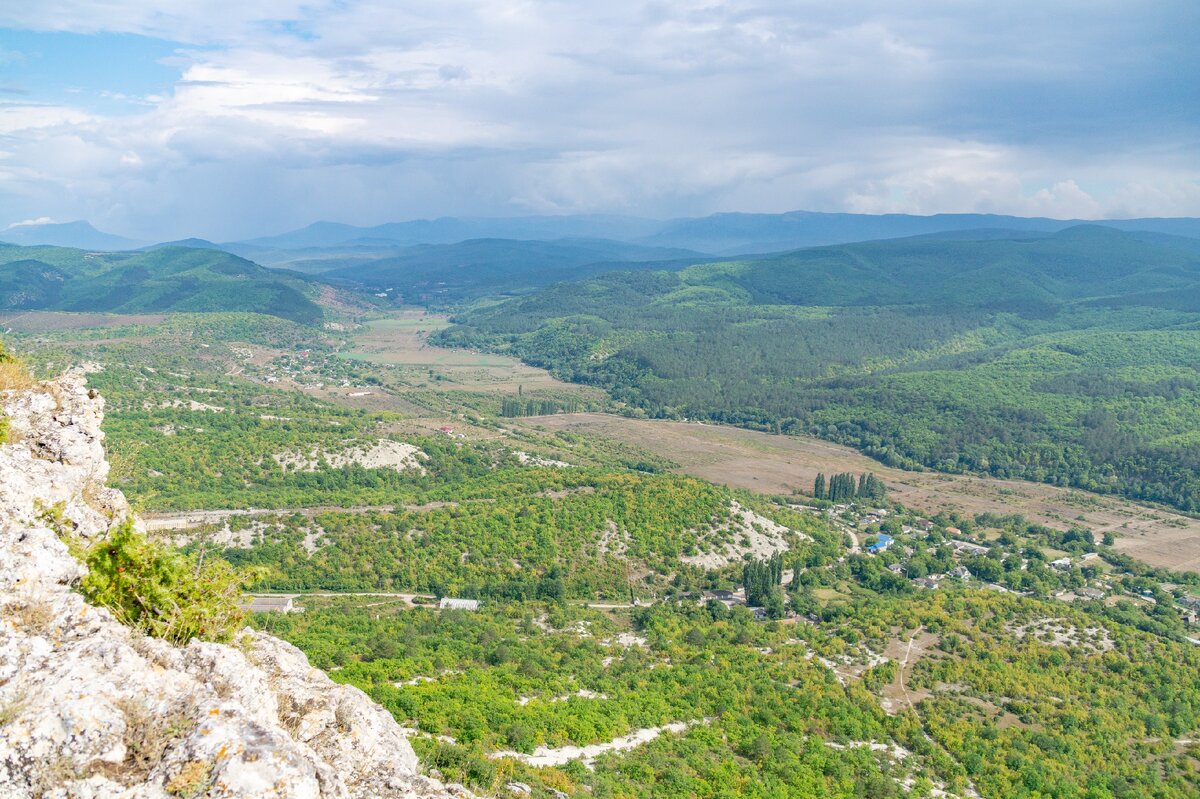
[0,377,469,799]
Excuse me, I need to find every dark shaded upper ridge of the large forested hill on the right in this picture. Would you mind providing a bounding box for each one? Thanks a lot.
[652,226,1200,311]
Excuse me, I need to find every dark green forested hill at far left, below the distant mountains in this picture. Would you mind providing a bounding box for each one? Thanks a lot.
[0,245,324,324]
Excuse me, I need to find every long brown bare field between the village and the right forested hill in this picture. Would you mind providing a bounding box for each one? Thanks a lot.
[521,414,1200,571]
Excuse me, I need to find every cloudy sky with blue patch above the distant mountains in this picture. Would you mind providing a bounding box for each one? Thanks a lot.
[0,0,1200,241]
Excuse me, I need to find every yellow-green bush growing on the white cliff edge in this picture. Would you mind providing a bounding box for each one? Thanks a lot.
[73,521,245,644]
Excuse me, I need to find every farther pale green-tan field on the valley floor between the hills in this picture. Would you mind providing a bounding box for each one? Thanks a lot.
[340,310,578,394]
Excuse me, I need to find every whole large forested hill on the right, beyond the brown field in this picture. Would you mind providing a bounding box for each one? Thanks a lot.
[442,227,1200,510]
